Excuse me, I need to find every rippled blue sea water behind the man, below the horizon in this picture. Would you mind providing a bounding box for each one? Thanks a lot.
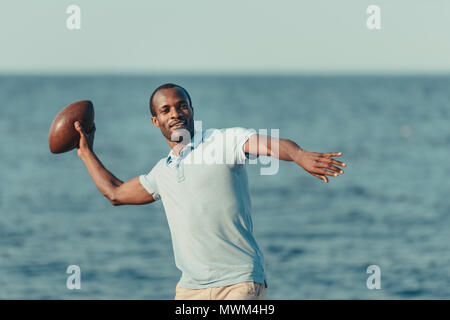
[0,76,450,299]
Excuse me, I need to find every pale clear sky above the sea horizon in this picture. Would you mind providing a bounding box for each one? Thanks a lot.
[0,0,450,74]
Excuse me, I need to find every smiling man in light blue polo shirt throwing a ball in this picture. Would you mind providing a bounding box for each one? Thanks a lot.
[75,84,346,300]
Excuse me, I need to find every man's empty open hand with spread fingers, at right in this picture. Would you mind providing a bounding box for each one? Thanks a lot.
[294,150,347,183]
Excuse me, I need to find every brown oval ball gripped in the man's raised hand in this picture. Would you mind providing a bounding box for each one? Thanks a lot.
[48,100,94,153]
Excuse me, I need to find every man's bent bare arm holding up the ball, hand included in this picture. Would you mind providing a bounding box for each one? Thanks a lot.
[74,121,155,206]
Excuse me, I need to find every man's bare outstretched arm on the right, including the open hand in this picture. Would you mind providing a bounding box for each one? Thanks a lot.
[244,134,347,182]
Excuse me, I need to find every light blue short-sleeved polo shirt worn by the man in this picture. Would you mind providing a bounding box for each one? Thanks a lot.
[139,127,265,289]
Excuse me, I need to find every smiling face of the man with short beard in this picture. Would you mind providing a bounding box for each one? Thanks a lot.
[152,88,194,141]
